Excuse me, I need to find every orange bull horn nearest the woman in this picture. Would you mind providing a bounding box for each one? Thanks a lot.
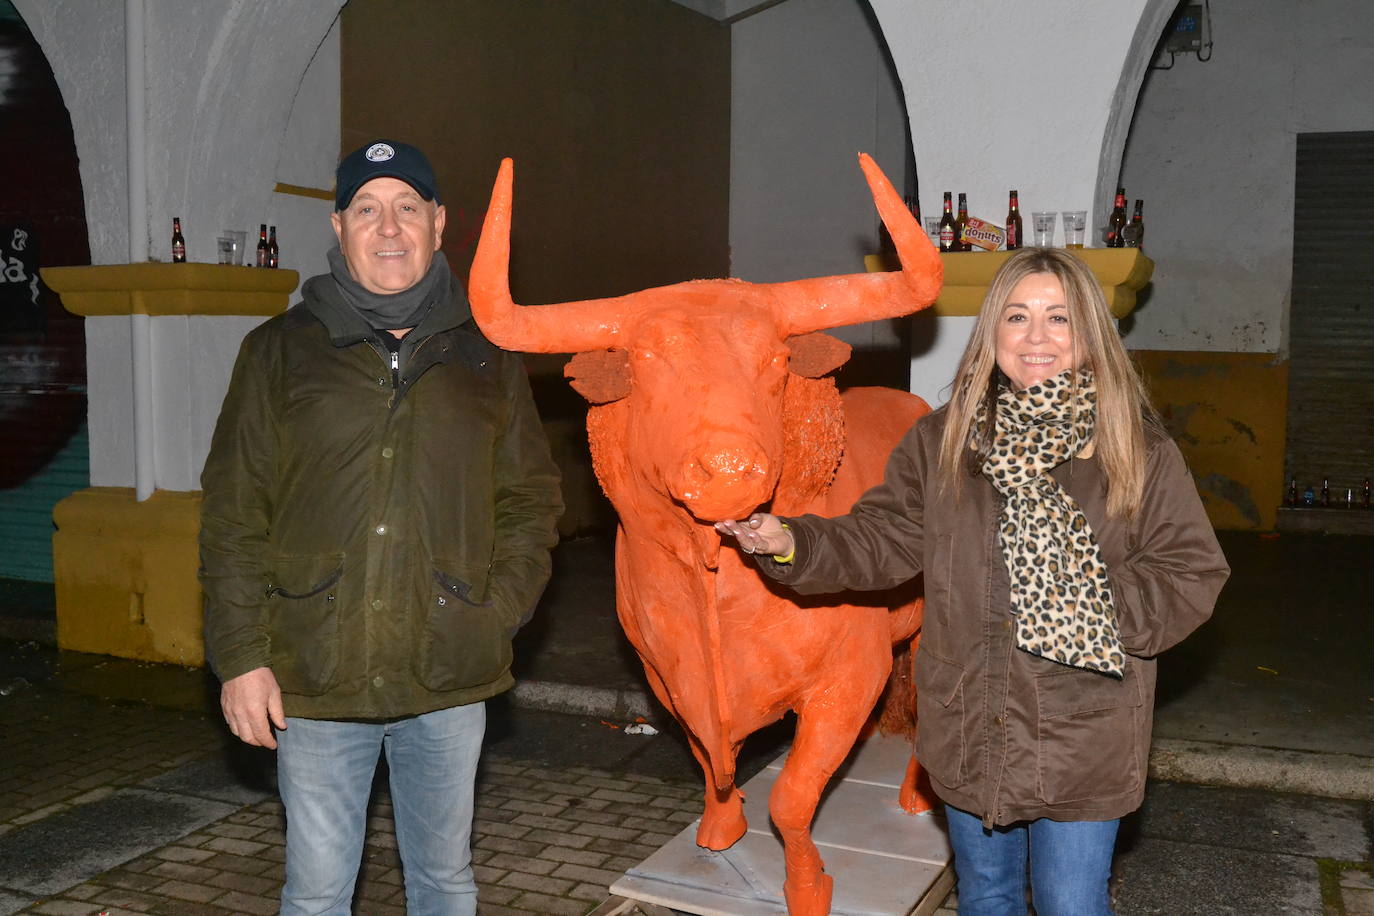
[768,152,944,340]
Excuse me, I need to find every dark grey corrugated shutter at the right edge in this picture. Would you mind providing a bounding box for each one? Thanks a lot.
[1285,130,1374,504]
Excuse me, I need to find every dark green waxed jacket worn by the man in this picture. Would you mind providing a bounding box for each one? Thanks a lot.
[201,277,562,718]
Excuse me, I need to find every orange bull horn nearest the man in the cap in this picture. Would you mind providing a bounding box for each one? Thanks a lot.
[467,159,632,353]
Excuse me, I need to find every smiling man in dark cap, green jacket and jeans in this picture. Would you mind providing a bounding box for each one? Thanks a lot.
[201,140,562,915]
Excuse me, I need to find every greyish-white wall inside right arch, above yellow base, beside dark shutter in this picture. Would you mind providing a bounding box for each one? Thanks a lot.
[1123,0,1374,353]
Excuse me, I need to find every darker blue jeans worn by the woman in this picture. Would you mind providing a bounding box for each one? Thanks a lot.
[945,805,1120,916]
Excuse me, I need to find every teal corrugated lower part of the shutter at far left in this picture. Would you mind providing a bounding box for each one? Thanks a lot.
[0,423,91,582]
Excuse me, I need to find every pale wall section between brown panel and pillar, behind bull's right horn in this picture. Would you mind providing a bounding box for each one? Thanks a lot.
[730,0,905,347]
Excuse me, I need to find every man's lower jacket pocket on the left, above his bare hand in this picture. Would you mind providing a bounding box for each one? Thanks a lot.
[267,553,344,696]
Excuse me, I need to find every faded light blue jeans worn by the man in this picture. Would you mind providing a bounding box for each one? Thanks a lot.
[276,703,486,916]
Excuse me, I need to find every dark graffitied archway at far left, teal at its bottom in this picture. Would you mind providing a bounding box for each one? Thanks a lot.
[0,0,91,581]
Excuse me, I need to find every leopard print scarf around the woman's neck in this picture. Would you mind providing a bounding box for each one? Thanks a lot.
[978,369,1125,677]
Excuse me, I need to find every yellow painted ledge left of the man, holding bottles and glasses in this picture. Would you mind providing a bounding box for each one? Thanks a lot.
[40,262,301,316]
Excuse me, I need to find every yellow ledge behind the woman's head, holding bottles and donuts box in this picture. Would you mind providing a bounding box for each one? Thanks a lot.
[864,249,1154,319]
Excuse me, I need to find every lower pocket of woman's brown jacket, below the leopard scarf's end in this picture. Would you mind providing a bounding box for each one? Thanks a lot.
[1035,659,1145,803]
